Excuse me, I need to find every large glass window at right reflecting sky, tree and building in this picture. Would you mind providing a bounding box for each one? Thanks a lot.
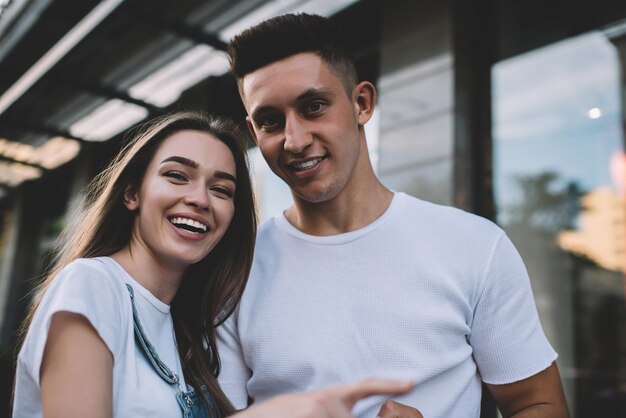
[492,32,626,417]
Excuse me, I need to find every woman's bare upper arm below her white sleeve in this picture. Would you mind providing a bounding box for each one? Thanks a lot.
[40,312,113,418]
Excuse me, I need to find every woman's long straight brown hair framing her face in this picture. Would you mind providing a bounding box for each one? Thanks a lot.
[22,112,257,417]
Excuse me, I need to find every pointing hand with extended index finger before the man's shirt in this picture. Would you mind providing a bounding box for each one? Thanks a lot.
[232,379,412,418]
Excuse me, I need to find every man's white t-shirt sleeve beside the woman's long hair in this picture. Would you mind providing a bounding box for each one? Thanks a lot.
[217,310,251,409]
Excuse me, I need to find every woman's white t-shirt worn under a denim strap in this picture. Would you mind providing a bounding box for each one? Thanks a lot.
[13,257,185,418]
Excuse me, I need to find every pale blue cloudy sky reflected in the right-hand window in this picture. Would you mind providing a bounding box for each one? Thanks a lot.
[493,33,624,217]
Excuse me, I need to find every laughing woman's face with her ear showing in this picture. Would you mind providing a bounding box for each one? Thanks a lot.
[124,130,236,271]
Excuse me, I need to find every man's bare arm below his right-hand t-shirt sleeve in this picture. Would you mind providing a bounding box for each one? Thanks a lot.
[487,363,569,418]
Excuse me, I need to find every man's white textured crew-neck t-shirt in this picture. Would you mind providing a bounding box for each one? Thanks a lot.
[218,193,556,418]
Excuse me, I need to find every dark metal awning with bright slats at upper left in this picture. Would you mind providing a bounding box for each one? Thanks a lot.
[0,0,356,193]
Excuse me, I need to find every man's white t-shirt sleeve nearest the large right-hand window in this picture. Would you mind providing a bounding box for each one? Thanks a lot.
[469,233,557,384]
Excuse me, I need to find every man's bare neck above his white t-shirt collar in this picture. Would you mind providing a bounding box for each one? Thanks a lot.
[285,176,393,236]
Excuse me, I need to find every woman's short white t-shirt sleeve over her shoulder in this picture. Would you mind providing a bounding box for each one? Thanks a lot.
[19,260,124,385]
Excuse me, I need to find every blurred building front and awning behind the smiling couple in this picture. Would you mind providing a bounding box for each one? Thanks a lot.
[0,0,626,418]
